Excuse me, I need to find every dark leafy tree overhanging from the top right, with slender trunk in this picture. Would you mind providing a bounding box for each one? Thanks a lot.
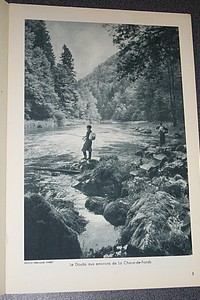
[109,25,182,126]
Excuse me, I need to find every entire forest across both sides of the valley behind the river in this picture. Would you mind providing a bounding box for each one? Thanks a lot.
[25,20,183,125]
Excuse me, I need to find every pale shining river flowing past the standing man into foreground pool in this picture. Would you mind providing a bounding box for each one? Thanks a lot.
[25,123,156,251]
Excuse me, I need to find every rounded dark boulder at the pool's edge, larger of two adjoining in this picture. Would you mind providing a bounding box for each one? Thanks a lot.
[103,200,130,226]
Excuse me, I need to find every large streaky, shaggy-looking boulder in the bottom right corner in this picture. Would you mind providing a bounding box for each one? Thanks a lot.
[122,191,192,256]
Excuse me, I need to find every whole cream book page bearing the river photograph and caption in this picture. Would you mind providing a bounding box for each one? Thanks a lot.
[6,5,200,293]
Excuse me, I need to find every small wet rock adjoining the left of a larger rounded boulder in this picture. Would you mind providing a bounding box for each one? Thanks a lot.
[85,197,108,215]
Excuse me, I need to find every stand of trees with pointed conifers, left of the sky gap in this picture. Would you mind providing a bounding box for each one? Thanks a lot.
[25,20,100,125]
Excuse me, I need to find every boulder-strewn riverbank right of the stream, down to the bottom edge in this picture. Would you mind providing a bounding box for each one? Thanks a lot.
[75,130,192,257]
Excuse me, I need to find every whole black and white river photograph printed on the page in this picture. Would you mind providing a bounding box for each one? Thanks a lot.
[24,19,193,261]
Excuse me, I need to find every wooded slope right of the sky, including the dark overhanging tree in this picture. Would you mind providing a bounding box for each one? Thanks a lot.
[79,25,183,125]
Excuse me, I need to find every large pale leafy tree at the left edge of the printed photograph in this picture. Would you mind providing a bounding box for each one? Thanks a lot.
[25,26,58,120]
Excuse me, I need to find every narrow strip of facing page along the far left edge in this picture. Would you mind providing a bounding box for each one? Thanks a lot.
[0,1,8,293]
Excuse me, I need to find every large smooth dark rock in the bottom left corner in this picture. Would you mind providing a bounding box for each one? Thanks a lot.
[25,195,81,260]
